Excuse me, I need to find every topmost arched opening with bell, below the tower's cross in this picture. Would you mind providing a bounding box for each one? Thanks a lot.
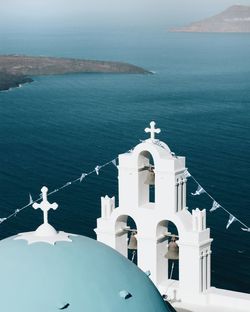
[138,151,155,206]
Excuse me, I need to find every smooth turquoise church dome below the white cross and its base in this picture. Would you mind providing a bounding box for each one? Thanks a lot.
[0,235,172,312]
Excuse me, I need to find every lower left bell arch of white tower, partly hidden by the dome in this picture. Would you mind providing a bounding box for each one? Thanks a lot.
[115,215,138,264]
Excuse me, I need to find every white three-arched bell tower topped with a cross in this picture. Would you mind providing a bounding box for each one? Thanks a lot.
[95,122,212,302]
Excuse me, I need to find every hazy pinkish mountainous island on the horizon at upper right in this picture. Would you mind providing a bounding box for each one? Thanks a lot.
[170,5,250,33]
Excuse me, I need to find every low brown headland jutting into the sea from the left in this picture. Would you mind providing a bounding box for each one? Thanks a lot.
[0,55,150,91]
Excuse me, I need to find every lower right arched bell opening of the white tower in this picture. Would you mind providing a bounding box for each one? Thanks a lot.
[156,220,179,284]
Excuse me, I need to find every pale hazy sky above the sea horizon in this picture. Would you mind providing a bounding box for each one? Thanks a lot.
[0,0,250,27]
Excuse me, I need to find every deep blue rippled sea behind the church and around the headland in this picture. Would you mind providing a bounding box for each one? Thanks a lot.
[0,29,250,292]
